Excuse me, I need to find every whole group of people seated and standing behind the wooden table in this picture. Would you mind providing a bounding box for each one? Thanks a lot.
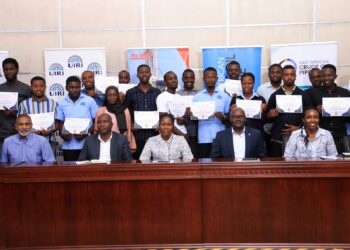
[0,58,350,163]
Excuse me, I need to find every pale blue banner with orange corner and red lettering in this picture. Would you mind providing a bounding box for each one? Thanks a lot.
[127,47,189,89]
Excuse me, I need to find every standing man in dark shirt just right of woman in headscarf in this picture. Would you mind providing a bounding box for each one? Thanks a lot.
[124,64,160,159]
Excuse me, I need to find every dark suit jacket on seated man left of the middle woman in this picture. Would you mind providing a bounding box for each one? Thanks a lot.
[78,132,133,161]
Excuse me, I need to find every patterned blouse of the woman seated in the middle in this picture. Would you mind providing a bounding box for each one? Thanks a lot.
[140,134,193,161]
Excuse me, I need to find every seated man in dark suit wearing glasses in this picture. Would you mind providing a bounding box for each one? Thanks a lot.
[210,108,266,159]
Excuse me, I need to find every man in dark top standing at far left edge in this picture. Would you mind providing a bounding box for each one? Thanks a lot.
[0,58,31,152]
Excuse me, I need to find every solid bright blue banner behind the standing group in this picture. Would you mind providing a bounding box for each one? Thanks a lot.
[202,46,262,90]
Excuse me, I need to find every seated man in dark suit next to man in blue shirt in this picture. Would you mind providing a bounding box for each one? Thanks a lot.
[79,113,133,162]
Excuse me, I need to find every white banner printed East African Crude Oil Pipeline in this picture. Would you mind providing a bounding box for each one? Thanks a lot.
[271,42,338,89]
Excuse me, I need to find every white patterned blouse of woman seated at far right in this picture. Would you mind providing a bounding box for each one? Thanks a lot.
[284,128,338,158]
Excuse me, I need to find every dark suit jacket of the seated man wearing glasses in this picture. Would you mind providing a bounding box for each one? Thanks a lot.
[210,126,266,158]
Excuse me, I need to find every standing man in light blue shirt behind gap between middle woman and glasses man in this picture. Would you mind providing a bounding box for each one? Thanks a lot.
[193,67,231,158]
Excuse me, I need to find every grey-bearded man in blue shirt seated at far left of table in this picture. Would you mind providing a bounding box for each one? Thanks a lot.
[1,115,56,163]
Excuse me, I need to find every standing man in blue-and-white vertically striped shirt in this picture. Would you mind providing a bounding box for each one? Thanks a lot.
[18,76,58,154]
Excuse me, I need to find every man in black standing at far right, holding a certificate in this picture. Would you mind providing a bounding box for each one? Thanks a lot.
[311,64,350,153]
